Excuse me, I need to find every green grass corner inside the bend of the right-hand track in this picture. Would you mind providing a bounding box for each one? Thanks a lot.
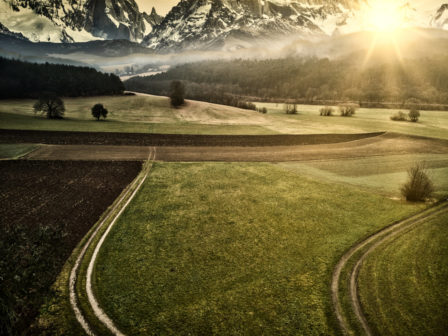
[359,213,448,336]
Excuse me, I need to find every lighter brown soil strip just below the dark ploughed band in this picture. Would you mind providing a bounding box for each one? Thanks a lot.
[25,133,448,162]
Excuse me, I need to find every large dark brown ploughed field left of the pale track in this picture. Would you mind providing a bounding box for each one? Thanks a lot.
[0,160,142,335]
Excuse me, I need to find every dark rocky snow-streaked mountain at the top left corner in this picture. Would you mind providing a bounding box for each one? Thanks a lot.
[0,0,161,42]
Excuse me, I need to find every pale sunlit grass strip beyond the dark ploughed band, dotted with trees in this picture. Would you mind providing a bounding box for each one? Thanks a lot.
[0,96,448,139]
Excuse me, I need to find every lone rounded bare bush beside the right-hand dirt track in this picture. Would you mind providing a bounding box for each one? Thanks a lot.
[401,163,434,202]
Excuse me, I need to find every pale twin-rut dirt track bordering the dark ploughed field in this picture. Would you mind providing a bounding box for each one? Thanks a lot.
[69,147,156,336]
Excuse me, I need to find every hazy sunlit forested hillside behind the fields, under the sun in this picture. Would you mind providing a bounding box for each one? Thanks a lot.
[125,56,448,104]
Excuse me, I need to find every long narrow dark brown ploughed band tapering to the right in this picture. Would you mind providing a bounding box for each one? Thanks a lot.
[0,130,383,147]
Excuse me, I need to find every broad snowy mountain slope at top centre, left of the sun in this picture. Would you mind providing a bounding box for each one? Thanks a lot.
[143,0,364,50]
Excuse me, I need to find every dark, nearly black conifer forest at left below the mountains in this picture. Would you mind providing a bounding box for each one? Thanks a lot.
[0,58,124,99]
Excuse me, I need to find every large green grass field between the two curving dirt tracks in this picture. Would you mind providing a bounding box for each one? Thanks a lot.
[94,163,422,335]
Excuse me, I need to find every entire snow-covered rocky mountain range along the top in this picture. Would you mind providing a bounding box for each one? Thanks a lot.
[0,0,448,53]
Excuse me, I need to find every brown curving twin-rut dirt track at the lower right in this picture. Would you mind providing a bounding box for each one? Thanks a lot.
[331,201,448,336]
